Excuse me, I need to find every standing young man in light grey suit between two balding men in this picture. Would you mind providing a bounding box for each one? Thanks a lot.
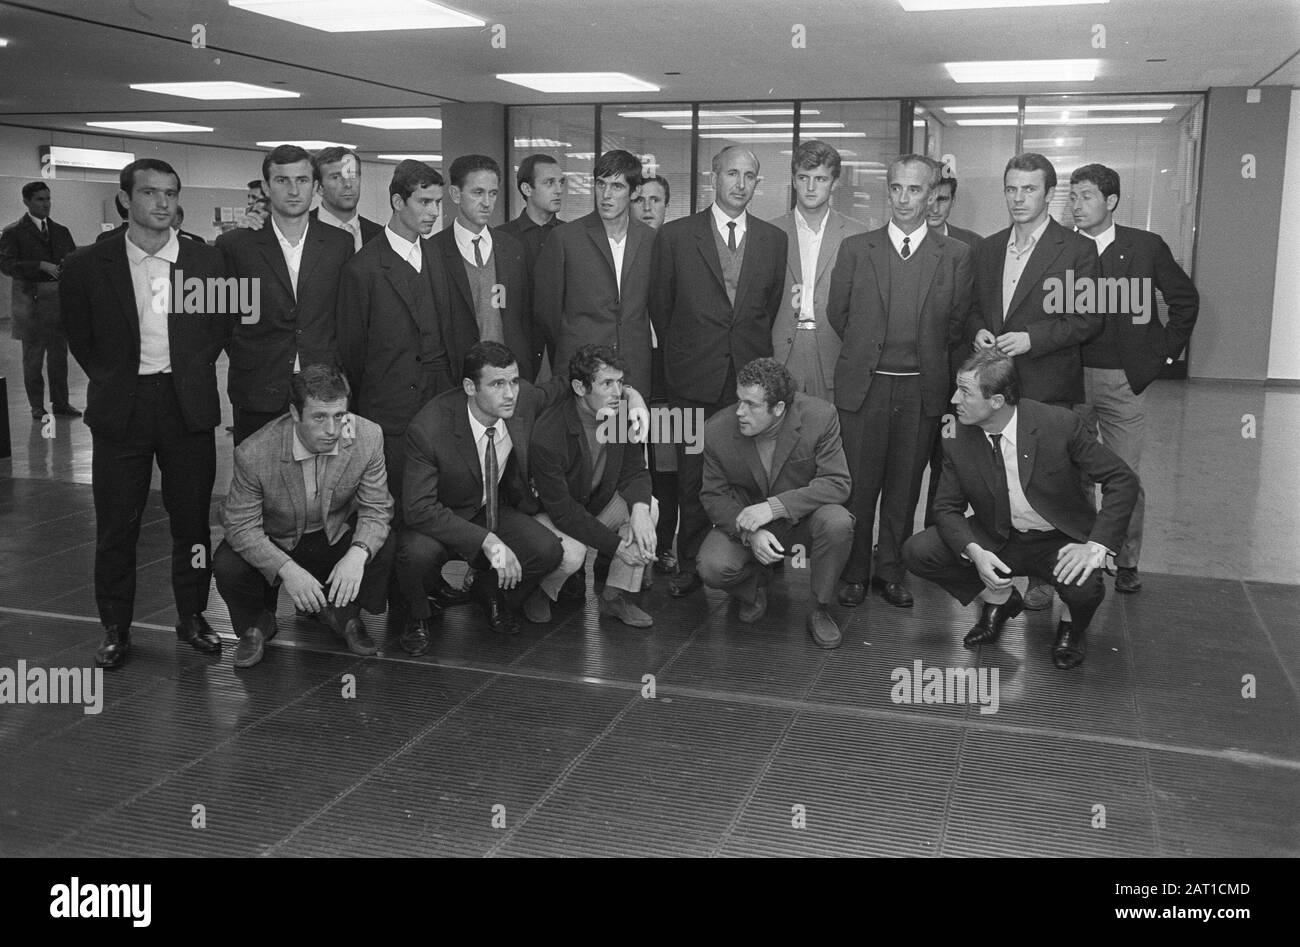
[772,139,867,401]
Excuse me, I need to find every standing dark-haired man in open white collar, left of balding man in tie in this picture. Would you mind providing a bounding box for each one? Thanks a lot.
[533,151,655,390]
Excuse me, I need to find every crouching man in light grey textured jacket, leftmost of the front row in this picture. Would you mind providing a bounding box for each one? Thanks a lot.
[212,364,395,667]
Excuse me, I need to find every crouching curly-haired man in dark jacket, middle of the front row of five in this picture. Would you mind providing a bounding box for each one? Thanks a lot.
[532,343,658,628]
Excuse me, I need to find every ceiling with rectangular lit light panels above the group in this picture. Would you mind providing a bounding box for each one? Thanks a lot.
[0,0,1300,153]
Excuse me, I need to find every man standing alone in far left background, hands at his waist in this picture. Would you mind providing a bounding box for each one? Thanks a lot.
[0,181,81,419]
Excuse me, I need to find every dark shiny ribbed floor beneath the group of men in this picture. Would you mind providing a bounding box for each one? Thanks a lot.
[0,342,1300,856]
